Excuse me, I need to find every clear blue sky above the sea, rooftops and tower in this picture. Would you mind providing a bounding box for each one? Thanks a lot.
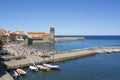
[0,0,120,35]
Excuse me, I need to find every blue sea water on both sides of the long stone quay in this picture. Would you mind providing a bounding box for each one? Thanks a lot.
[18,36,120,80]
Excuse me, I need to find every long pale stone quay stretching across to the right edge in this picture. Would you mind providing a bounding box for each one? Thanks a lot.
[1,46,120,80]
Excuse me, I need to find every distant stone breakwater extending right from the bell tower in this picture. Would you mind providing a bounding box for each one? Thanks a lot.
[55,37,84,42]
